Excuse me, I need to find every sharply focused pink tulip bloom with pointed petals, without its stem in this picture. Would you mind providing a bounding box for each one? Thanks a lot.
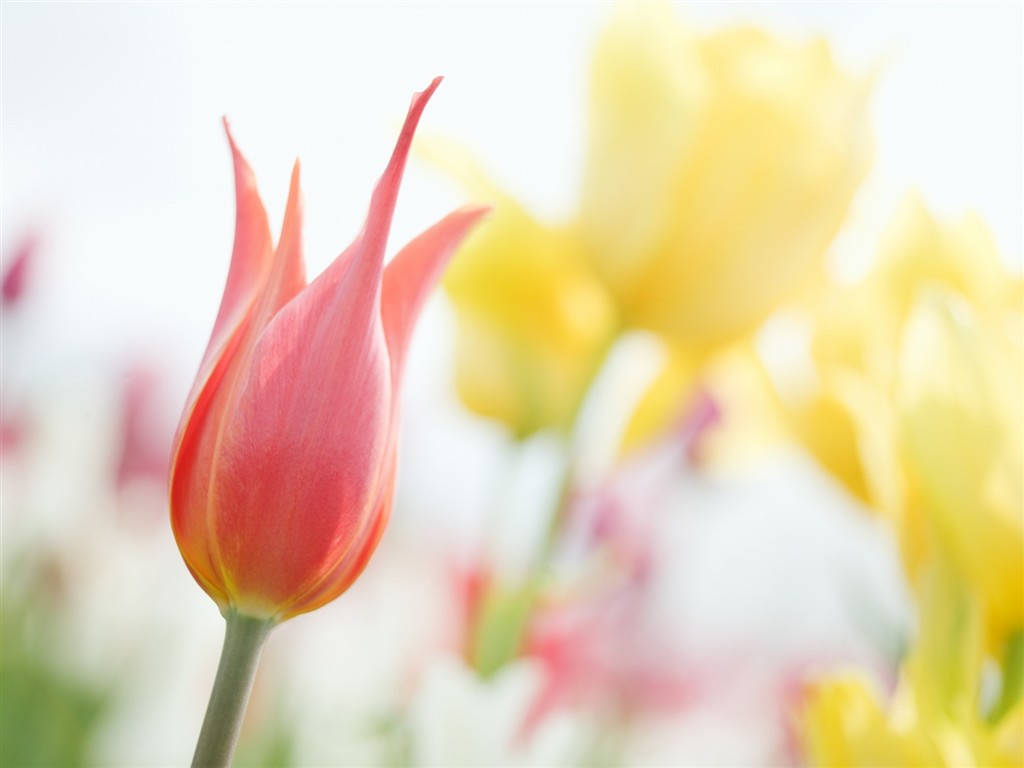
[170,79,484,622]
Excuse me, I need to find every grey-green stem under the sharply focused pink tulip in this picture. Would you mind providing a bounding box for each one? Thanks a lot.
[193,610,274,768]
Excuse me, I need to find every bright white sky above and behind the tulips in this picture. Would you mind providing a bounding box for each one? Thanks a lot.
[0,2,1024,368]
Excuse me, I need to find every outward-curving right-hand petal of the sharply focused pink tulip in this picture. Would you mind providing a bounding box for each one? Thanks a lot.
[381,206,490,382]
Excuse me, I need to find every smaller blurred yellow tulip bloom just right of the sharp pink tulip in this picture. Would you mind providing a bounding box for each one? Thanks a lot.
[421,139,617,437]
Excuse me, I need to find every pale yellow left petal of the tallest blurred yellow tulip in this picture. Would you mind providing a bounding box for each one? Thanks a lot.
[580,3,710,306]
